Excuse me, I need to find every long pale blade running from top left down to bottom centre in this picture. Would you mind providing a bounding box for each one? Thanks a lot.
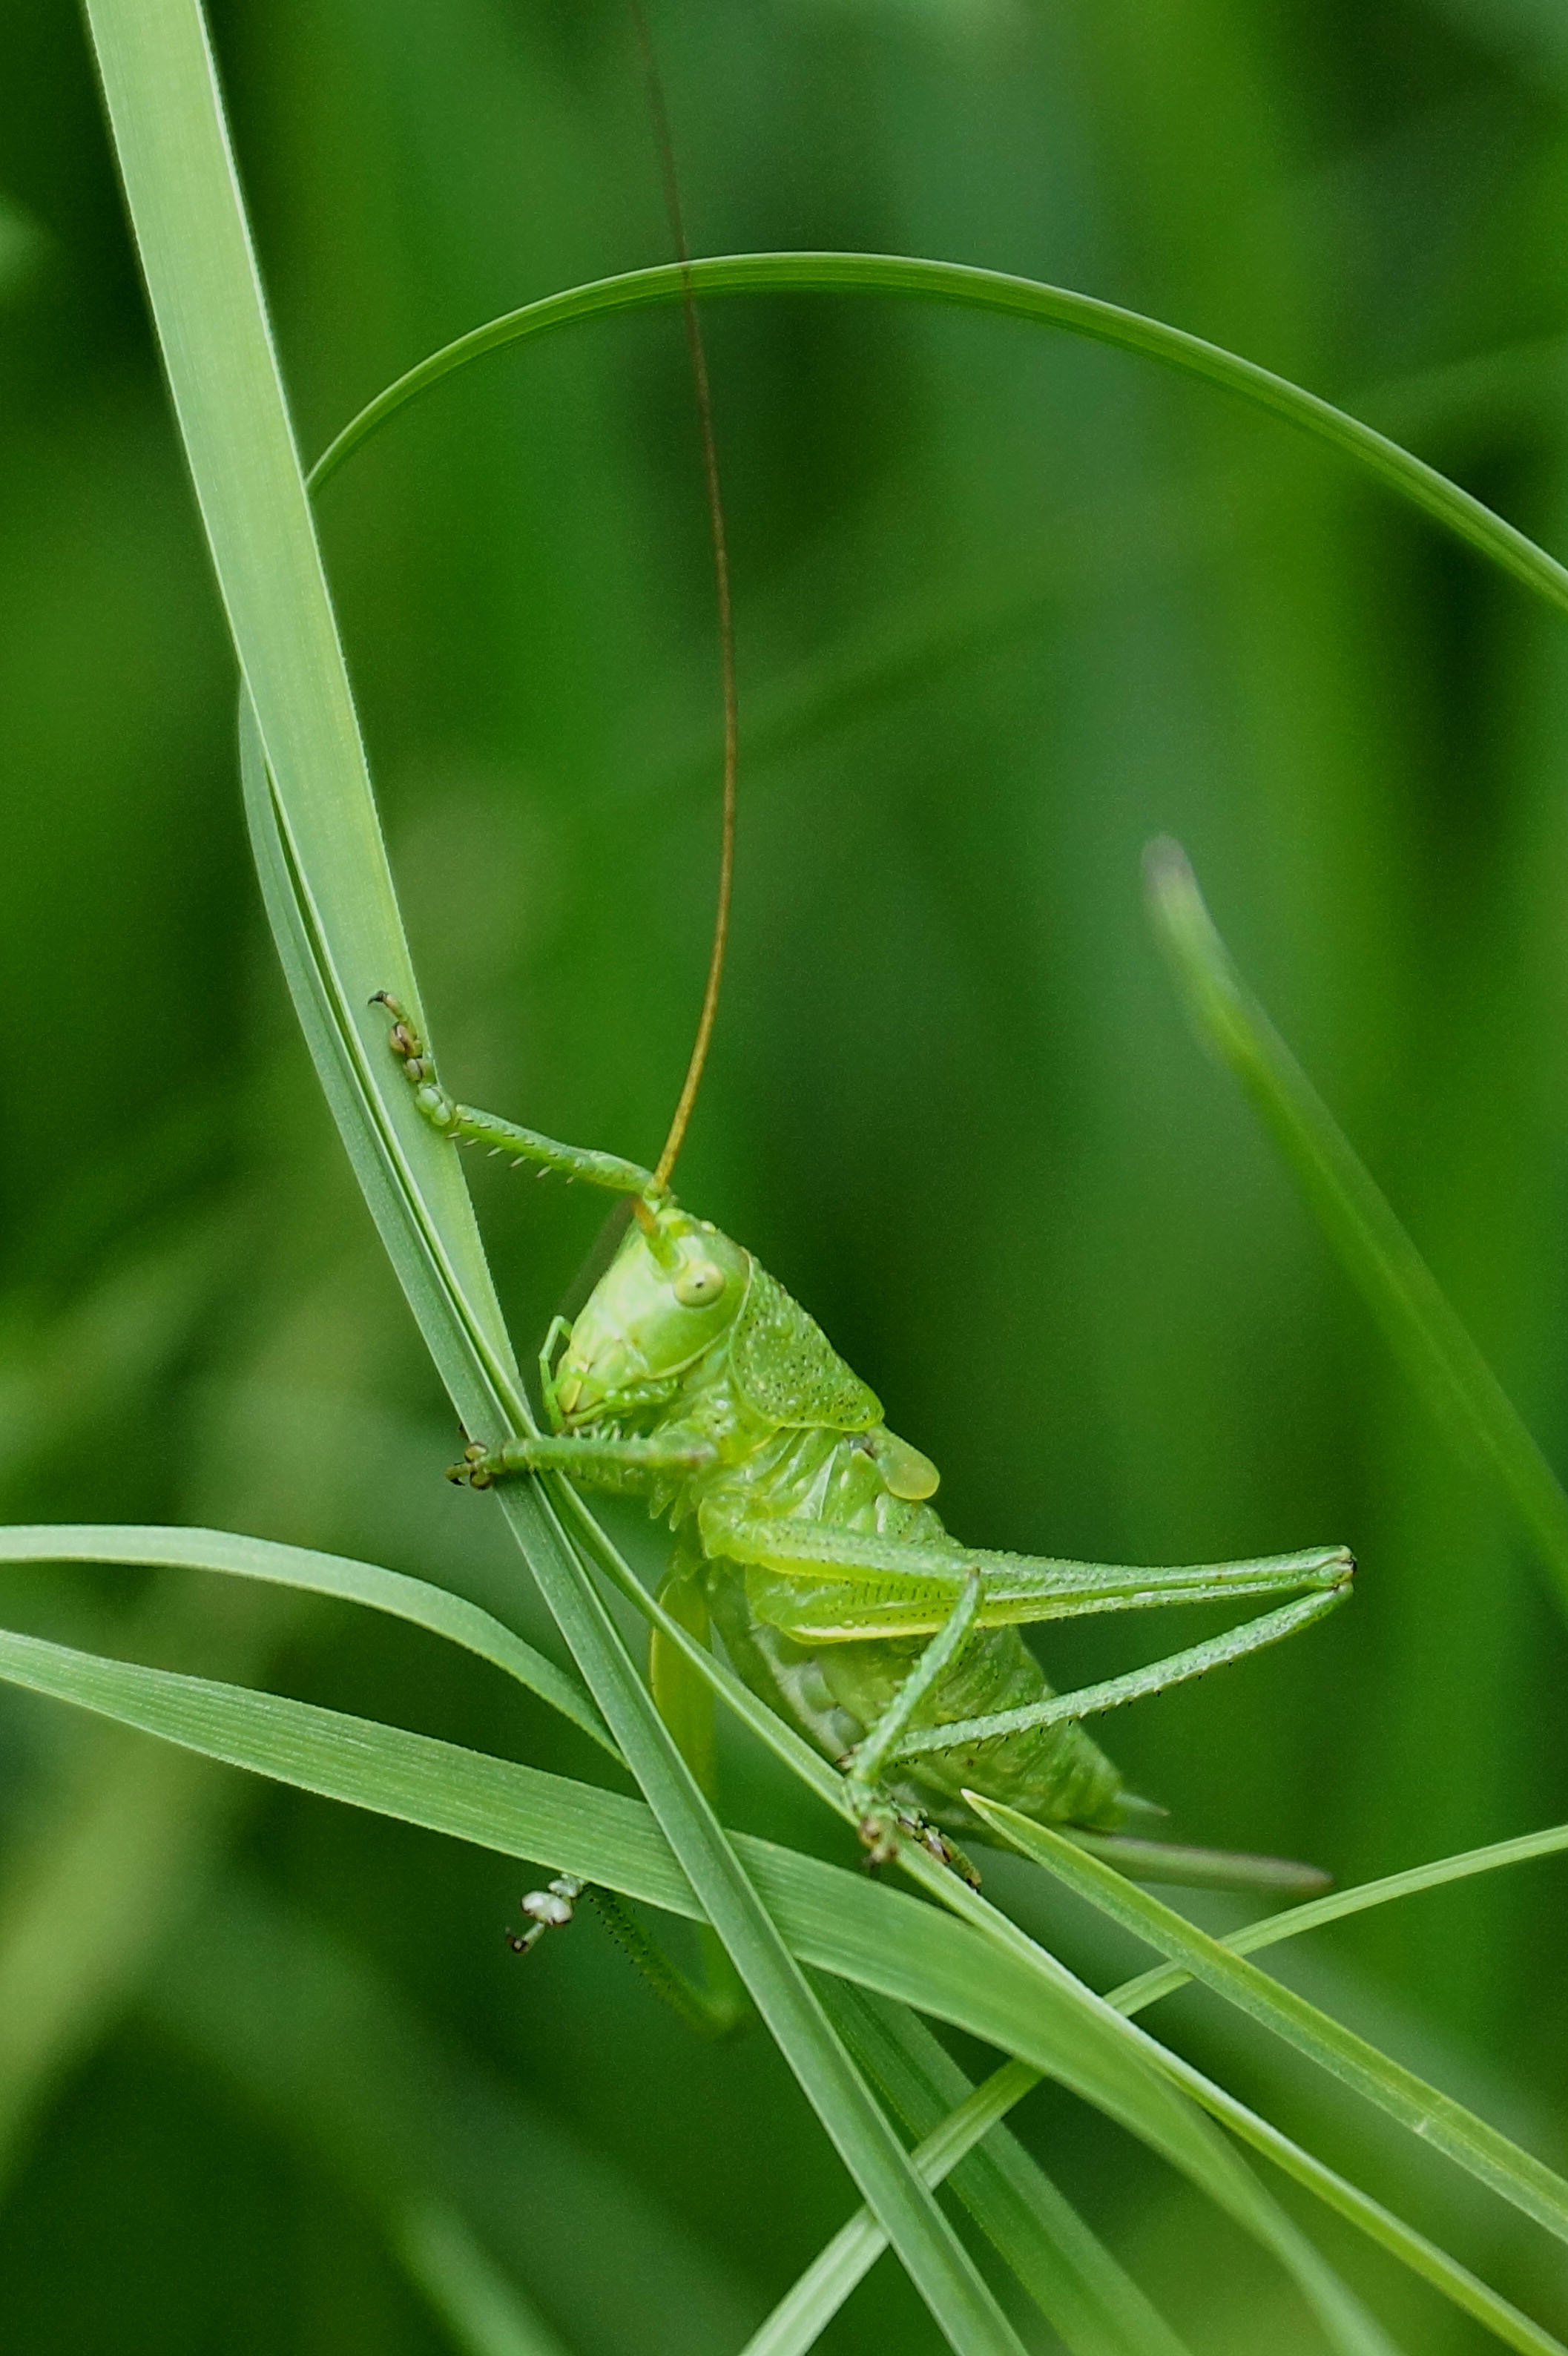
[76,0,1050,2356]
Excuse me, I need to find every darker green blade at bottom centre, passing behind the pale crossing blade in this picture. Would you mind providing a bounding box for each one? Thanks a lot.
[809,1981,1187,2356]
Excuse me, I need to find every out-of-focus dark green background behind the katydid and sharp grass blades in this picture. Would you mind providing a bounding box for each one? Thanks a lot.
[0,0,1568,2356]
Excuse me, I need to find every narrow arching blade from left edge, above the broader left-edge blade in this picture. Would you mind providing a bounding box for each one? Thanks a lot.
[0,1522,619,1757]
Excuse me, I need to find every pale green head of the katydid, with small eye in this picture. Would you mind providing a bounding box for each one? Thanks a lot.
[551,1204,751,1430]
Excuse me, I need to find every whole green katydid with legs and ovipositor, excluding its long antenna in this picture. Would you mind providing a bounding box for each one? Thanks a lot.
[386,1001,1354,1889]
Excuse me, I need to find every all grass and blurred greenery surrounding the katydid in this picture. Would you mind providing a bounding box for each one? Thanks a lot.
[0,0,1568,2356]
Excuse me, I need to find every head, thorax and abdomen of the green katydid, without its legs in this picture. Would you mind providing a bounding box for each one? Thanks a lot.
[551,1208,1130,1831]
